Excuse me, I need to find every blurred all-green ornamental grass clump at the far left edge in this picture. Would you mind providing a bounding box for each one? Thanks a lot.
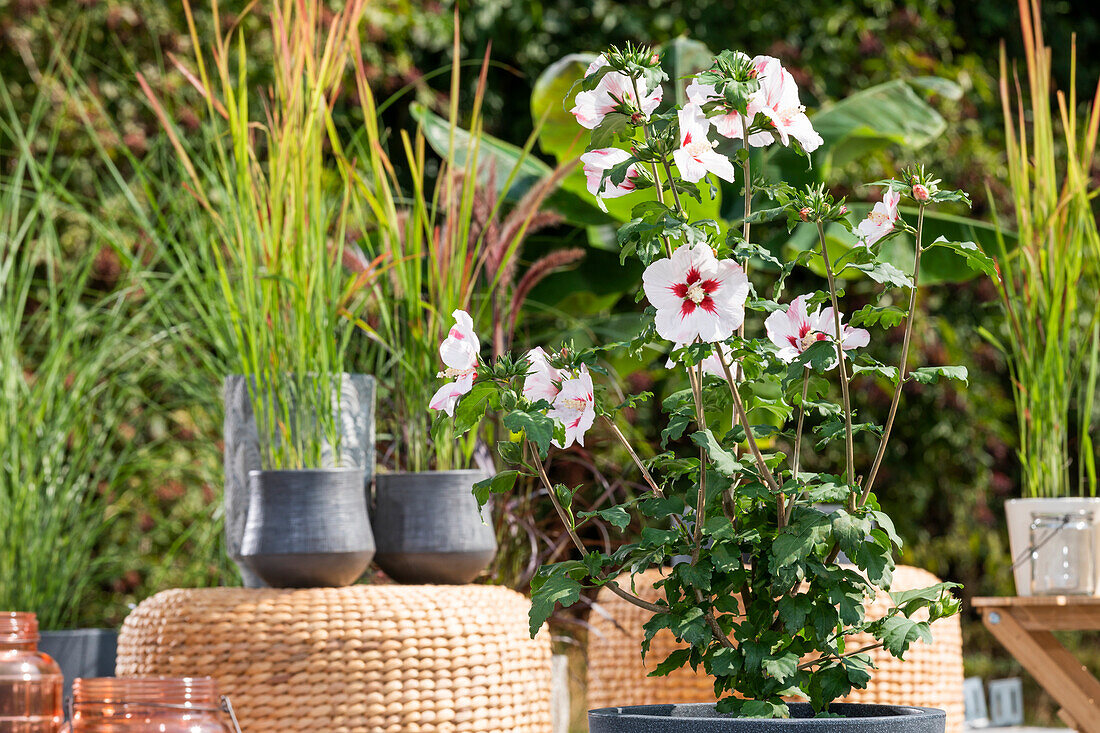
[0,79,157,628]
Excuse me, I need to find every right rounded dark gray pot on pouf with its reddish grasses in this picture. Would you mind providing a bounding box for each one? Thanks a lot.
[345,44,580,583]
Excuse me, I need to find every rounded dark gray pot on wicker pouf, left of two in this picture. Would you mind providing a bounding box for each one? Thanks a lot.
[241,469,374,588]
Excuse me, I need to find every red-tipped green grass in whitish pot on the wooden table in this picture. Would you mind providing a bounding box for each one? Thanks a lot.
[991,2,1100,595]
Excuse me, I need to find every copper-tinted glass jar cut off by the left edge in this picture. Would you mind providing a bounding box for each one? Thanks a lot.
[0,613,64,733]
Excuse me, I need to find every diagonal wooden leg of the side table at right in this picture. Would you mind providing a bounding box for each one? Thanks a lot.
[982,608,1100,733]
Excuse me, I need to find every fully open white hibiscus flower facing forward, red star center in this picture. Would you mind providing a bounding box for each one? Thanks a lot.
[641,244,749,343]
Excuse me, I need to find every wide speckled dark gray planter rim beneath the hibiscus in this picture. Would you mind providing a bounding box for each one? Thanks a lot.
[589,702,947,733]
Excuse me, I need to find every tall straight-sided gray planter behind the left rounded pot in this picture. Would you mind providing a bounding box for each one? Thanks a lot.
[223,374,374,588]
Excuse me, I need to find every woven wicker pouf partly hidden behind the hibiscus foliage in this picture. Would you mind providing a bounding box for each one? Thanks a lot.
[587,566,964,733]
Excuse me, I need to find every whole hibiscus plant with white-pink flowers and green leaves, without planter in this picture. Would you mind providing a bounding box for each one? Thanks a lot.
[432,46,989,716]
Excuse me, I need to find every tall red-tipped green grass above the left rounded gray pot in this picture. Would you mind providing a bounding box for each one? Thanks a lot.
[139,0,365,469]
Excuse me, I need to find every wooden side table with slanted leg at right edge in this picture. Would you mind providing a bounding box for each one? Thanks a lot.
[972,595,1100,733]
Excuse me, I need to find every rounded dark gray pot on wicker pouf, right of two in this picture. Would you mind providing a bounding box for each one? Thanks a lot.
[371,470,496,584]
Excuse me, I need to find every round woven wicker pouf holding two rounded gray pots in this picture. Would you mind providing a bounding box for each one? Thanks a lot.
[117,586,551,733]
